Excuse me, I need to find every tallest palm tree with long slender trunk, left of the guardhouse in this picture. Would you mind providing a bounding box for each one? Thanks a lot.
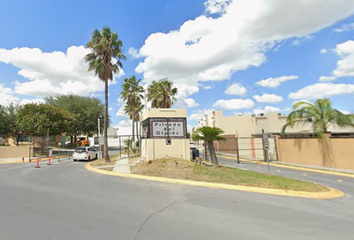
[84,26,126,162]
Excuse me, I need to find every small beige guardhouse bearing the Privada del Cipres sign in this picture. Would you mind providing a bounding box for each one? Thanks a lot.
[140,108,190,161]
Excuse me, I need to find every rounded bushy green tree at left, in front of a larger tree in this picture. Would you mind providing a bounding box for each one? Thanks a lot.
[16,103,73,136]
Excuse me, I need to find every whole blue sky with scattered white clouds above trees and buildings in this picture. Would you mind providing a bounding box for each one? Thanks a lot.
[0,0,354,131]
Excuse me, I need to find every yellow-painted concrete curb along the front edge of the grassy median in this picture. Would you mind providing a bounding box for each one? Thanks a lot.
[85,163,345,199]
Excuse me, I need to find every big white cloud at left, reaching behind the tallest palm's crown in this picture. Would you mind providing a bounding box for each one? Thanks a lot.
[0,46,124,97]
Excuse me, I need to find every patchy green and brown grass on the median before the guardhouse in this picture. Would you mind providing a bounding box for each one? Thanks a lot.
[132,159,329,192]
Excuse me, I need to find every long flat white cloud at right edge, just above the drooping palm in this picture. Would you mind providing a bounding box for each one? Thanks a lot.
[289,83,354,99]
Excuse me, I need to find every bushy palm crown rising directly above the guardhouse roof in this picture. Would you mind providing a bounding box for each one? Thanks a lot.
[147,78,177,108]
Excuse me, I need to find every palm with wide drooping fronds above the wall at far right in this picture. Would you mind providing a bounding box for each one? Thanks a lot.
[282,98,354,137]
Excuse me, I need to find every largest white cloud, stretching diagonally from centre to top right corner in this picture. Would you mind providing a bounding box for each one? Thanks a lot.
[136,0,354,94]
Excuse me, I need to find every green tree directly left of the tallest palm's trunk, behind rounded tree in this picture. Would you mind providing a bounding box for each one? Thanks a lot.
[45,94,104,141]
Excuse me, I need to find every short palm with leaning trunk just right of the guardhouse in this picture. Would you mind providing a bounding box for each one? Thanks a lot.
[192,126,225,168]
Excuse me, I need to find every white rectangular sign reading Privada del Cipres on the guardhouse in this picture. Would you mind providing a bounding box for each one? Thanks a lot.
[151,120,184,137]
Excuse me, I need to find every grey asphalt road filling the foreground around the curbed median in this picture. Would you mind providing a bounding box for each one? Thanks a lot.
[0,155,354,240]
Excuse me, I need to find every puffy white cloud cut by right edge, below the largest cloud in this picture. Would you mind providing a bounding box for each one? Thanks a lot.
[319,40,354,82]
